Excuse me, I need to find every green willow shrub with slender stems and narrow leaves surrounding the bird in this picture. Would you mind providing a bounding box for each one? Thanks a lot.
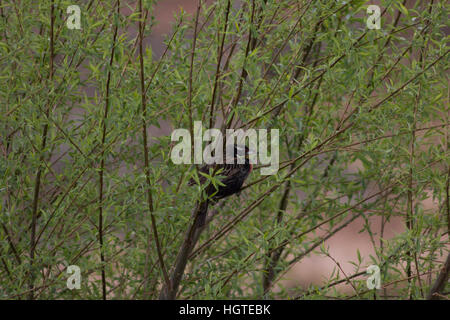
[0,0,450,299]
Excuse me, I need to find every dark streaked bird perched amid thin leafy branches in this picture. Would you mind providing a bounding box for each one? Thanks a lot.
[188,145,253,226]
